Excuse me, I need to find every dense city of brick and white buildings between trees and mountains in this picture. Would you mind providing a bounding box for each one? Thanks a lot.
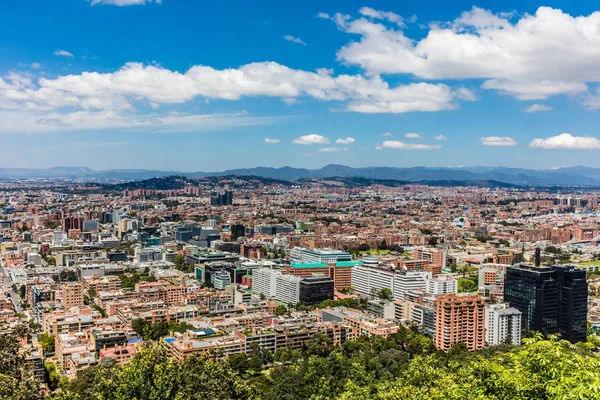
[0,177,600,392]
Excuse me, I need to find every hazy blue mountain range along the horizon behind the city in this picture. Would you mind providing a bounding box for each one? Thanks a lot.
[0,164,600,186]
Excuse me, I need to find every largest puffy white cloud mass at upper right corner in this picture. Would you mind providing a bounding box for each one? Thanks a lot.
[330,7,600,100]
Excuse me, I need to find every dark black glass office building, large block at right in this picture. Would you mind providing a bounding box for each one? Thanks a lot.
[504,264,588,342]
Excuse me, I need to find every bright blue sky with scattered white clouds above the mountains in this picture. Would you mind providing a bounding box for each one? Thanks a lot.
[0,0,600,171]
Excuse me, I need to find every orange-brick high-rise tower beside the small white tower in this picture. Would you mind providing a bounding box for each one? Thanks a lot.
[434,294,485,351]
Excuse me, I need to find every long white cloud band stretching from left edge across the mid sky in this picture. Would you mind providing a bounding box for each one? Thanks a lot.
[0,62,464,113]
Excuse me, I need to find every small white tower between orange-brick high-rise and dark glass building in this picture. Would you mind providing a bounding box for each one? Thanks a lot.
[484,303,521,345]
